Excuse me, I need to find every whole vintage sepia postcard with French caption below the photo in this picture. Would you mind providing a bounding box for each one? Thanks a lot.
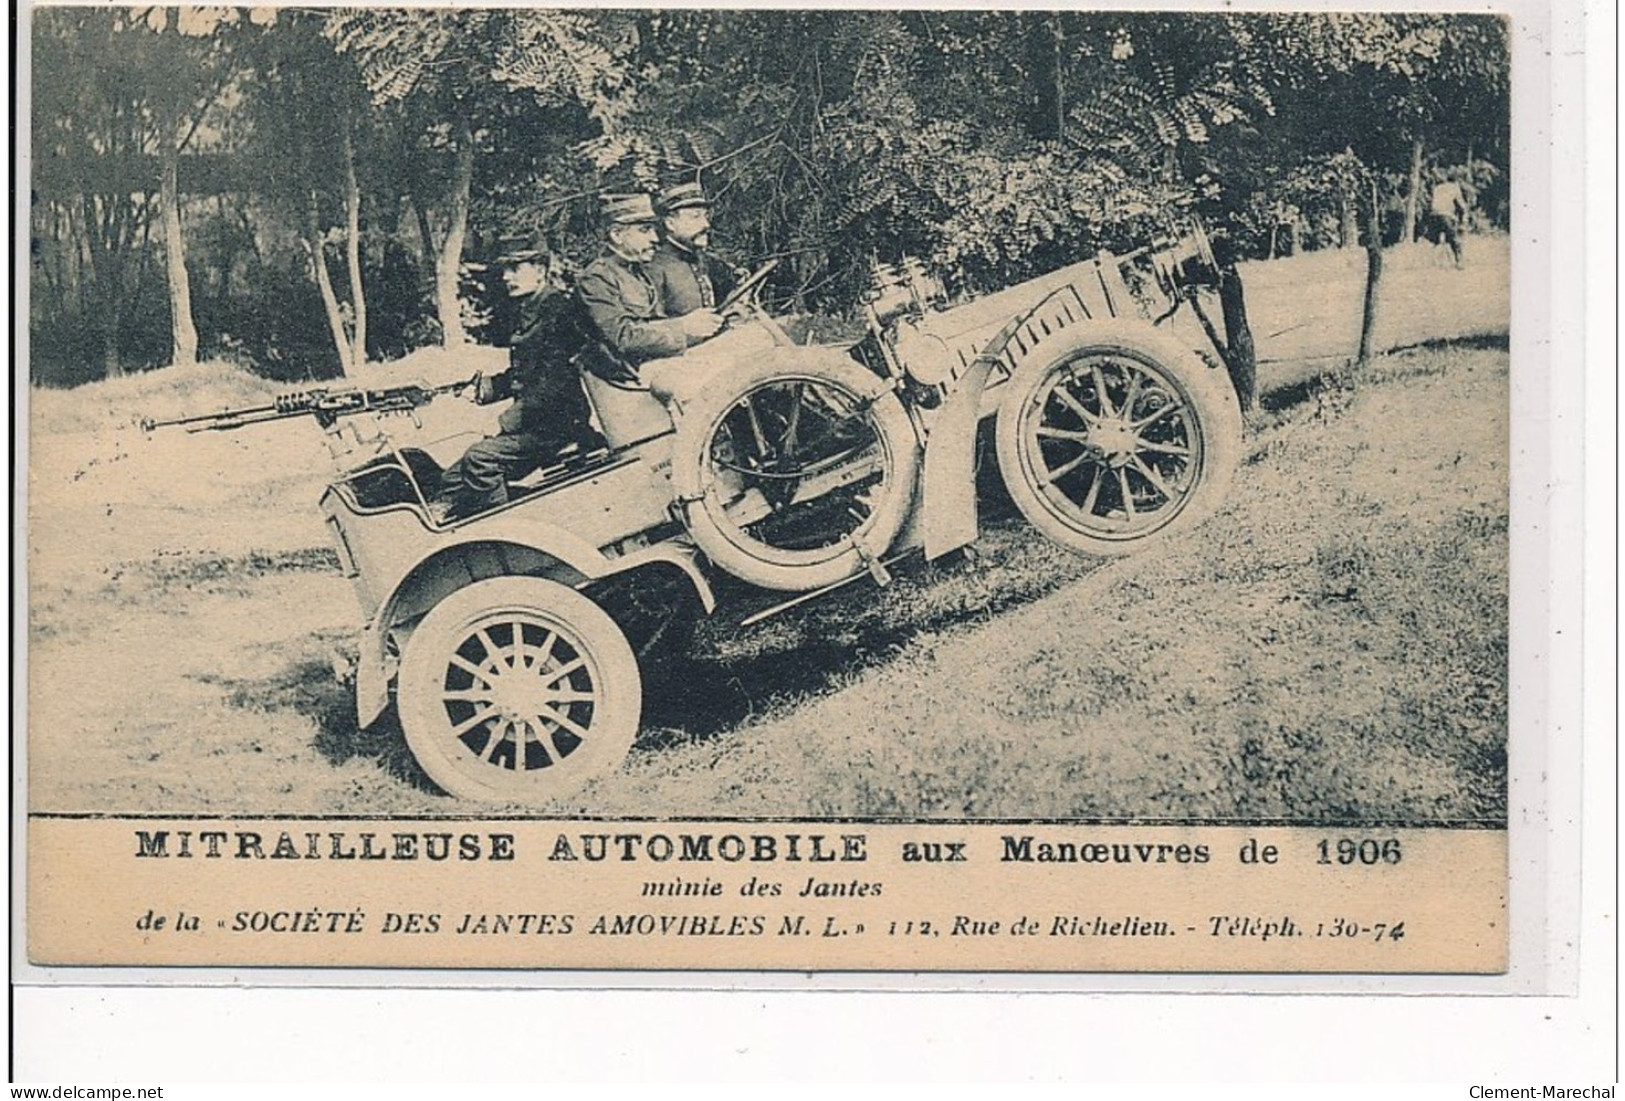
[16,5,1527,981]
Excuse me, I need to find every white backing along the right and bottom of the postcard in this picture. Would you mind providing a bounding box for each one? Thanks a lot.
[8,0,1619,1098]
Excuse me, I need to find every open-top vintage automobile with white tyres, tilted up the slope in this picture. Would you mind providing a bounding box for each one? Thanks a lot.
[307,234,1242,802]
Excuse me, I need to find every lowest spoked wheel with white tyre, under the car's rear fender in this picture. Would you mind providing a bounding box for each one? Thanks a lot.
[397,576,642,802]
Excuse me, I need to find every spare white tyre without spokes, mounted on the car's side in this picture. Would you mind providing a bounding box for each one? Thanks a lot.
[671,349,920,591]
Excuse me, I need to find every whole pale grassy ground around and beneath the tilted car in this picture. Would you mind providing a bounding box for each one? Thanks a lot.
[28,243,1508,823]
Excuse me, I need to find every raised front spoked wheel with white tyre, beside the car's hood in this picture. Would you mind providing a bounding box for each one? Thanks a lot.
[995,322,1242,555]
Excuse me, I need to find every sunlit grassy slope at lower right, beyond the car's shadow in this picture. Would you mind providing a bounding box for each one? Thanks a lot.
[583,351,1506,822]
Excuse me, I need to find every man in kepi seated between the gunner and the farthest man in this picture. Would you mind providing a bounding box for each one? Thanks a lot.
[575,193,722,393]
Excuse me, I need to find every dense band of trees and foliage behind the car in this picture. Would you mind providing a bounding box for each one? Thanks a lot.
[31,6,1510,383]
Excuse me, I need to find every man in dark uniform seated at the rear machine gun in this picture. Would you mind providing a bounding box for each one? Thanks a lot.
[440,241,603,520]
